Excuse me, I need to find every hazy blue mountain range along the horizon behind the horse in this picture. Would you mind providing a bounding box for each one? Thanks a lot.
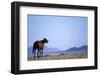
[28,45,88,56]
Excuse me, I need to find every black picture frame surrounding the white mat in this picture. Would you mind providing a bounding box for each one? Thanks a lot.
[11,2,98,74]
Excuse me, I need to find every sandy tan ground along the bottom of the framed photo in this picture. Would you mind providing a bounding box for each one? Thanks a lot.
[28,52,88,61]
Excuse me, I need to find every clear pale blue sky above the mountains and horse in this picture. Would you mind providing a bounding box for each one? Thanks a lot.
[28,15,88,50]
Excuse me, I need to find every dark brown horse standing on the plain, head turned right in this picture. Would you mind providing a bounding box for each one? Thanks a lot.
[32,38,48,59]
